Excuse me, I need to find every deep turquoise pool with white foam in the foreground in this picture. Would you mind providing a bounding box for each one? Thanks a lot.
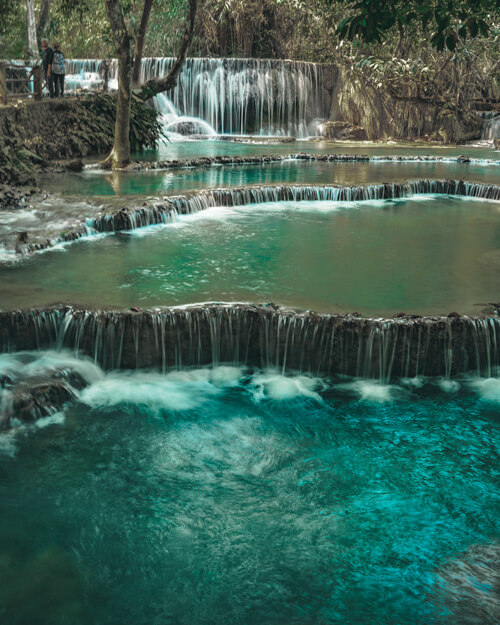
[0,354,500,625]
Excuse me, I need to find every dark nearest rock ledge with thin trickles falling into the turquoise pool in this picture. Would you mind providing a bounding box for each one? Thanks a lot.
[0,303,500,382]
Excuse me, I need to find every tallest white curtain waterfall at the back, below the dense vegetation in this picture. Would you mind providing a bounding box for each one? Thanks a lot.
[67,58,327,137]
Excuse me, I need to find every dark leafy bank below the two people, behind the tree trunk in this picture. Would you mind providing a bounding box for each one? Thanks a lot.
[0,94,161,185]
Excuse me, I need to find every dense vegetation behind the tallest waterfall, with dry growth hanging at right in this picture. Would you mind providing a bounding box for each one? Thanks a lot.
[0,0,500,163]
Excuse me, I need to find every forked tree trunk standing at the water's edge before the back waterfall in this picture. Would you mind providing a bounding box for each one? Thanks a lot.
[104,0,198,169]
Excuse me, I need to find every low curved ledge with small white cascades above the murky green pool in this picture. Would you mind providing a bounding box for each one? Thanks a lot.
[90,180,500,232]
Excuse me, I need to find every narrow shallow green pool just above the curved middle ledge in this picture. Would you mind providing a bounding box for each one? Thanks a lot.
[50,161,500,196]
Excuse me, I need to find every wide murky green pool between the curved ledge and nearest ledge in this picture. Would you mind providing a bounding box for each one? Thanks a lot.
[0,196,500,315]
